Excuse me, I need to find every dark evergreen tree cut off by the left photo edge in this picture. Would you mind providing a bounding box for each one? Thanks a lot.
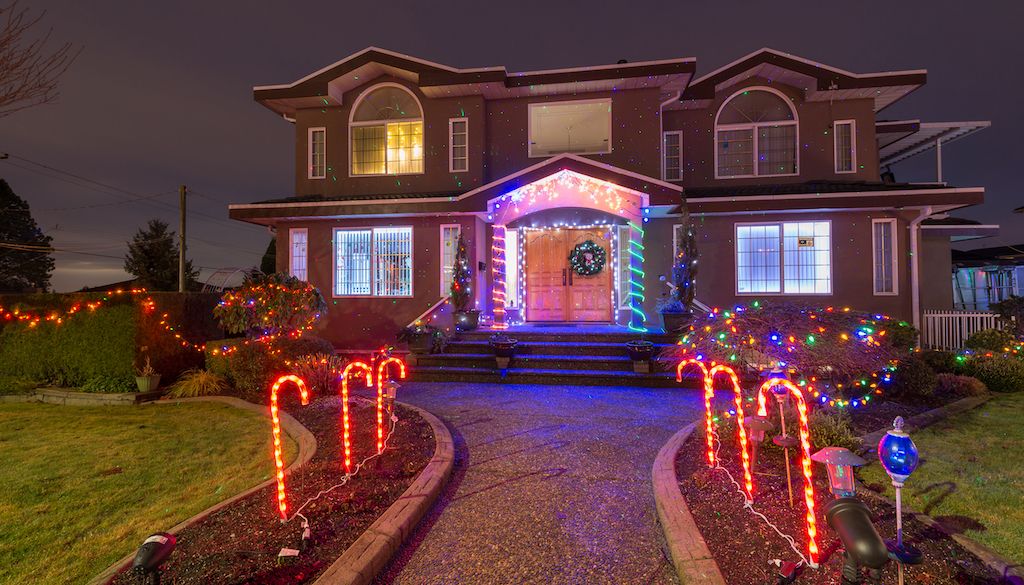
[0,179,53,292]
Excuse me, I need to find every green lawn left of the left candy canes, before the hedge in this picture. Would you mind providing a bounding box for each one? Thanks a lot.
[0,404,296,583]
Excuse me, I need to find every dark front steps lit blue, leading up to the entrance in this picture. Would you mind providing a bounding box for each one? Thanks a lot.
[410,326,679,387]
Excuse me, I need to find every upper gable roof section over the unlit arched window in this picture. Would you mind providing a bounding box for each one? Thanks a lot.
[681,47,928,112]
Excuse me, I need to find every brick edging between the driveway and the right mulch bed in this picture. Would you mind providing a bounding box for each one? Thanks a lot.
[651,423,725,585]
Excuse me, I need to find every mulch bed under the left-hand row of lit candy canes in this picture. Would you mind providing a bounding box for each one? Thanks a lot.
[115,396,434,585]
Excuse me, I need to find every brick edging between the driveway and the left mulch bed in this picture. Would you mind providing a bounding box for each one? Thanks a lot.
[313,403,455,585]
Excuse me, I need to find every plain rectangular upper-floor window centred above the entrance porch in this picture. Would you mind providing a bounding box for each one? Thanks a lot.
[529,98,611,157]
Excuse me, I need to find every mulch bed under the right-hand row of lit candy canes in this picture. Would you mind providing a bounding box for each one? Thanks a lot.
[676,422,999,585]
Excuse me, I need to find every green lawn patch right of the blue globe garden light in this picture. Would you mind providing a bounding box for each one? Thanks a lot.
[860,393,1024,562]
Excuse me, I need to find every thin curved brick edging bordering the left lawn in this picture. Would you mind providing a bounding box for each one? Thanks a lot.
[89,396,316,585]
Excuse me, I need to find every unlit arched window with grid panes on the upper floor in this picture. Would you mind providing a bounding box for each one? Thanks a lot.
[715,88,798,178]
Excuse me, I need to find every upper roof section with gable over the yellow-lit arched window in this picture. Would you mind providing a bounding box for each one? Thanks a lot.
[253,47,696,116]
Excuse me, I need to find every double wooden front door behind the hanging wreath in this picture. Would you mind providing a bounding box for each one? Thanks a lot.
[525,228,615,322]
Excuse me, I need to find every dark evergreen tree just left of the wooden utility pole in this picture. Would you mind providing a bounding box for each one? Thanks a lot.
[125,219,199,291]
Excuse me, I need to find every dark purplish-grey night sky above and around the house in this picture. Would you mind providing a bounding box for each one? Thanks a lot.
[0,0,1024,291]
